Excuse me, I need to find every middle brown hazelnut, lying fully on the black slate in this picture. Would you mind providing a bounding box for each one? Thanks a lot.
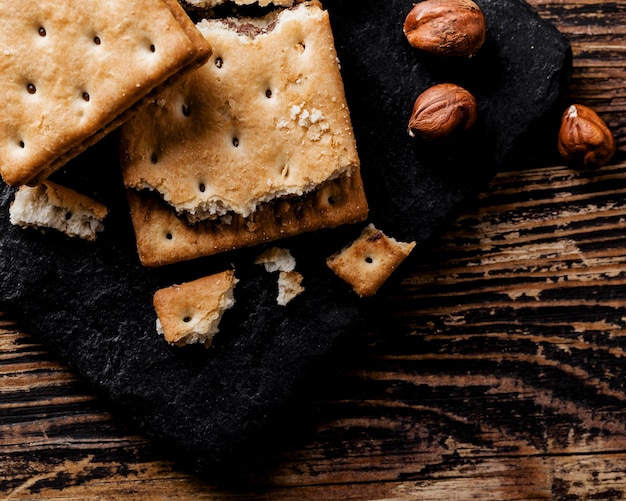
[408,83,478,141]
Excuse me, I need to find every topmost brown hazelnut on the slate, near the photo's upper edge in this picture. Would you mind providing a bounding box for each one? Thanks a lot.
[404,0,487,57]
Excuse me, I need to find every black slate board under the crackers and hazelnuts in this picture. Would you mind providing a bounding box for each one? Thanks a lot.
[0,0,571,467]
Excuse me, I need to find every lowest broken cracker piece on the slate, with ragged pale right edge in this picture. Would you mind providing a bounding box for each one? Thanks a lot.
[153,270,238,348]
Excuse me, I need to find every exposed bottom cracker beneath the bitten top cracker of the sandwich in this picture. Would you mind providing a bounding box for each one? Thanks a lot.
[128,170,368,267]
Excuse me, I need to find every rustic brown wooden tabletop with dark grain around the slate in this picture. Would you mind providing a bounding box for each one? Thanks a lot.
[0,0,626,500]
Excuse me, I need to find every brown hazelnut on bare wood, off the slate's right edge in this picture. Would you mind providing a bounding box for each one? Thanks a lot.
[558,104,615,167]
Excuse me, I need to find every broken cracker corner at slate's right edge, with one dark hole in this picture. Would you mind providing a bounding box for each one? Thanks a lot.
[326,224,415,297]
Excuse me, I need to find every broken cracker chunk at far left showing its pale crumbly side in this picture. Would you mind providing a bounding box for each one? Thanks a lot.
[9,181,108,240]
